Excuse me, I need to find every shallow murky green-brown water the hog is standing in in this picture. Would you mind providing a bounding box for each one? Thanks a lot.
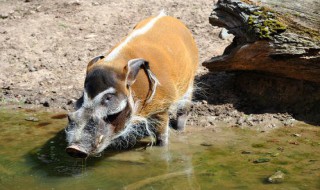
[0,109,320,189]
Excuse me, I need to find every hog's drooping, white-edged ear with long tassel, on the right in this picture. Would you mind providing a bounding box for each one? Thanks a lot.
[124,59,160,103]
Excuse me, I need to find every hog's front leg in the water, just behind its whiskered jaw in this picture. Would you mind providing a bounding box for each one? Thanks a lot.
[154,112,169,146]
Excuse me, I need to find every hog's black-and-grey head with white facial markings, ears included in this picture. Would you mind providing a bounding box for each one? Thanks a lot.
[65,56,157,158]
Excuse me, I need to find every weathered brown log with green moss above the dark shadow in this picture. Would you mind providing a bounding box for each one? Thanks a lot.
[203,0,320,83]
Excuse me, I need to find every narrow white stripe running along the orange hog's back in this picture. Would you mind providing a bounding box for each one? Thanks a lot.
[104,10,166,62]
